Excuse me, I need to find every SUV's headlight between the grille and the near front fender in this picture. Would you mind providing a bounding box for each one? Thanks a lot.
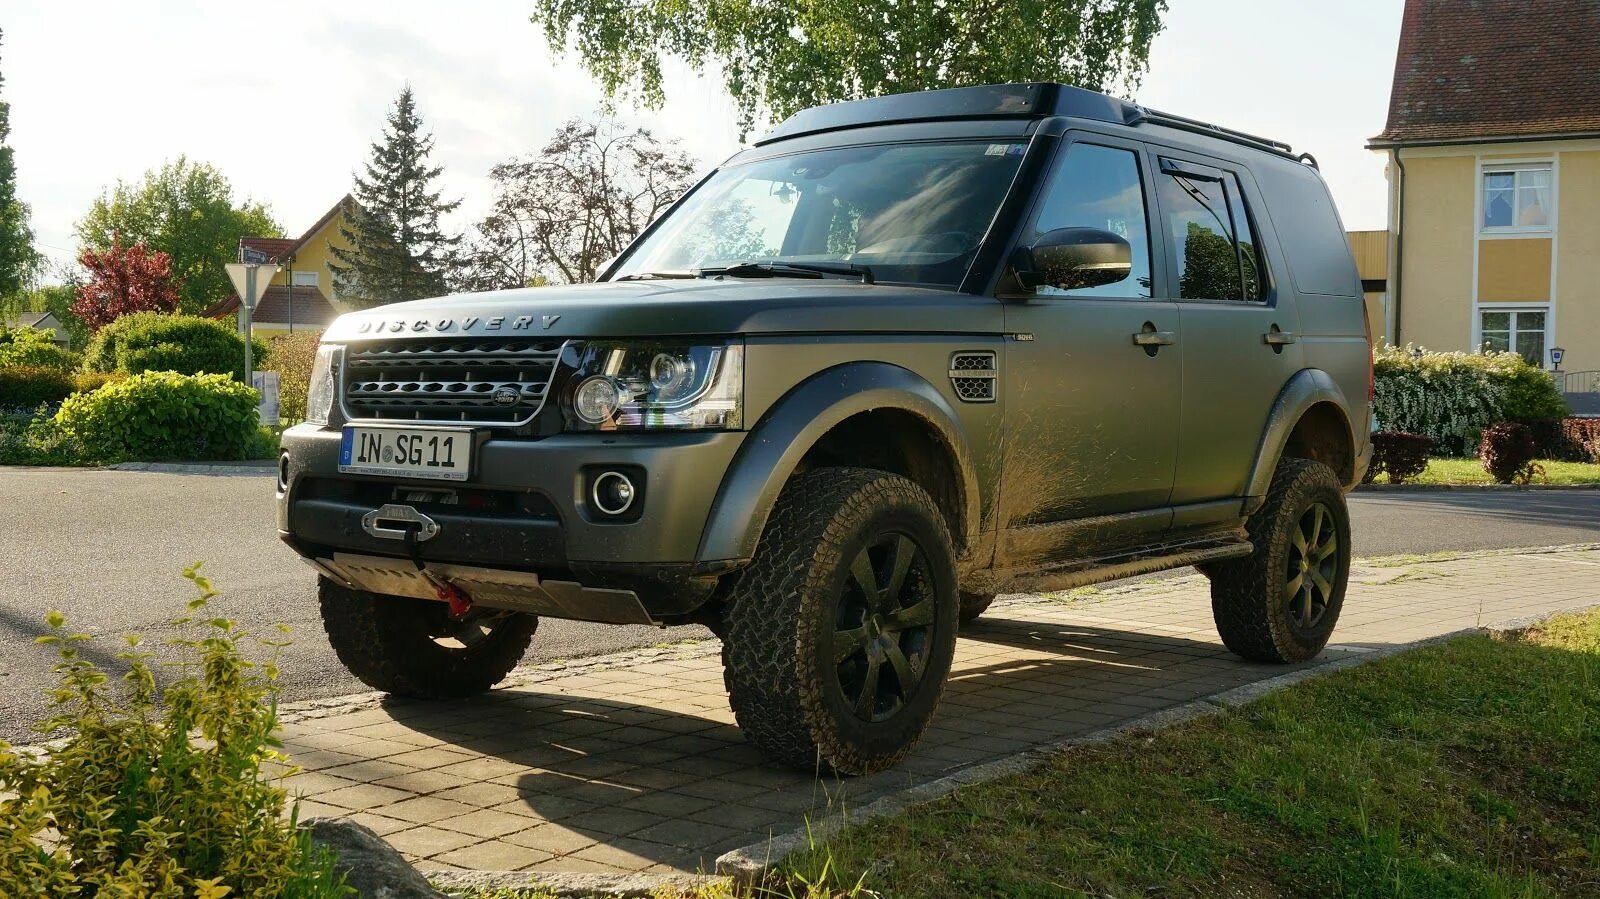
[562,341,744,430]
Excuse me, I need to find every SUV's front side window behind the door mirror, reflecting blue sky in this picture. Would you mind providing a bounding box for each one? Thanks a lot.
[1026,144,1150,296]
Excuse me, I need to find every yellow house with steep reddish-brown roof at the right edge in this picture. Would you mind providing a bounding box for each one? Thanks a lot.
[1363,0,1600,383]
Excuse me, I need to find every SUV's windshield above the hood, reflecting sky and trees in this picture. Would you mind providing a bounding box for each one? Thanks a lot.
[611,141,1027,286]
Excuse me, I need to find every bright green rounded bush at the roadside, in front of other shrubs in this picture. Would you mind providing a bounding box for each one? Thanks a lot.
[56,371,259,462]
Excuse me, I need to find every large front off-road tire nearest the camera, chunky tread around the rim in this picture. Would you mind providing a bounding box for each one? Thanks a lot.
[722,469,958,774]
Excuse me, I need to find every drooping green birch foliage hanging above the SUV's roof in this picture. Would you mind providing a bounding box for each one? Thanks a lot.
[533,0,1166,130]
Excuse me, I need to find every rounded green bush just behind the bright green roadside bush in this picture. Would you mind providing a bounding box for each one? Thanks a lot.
[83,312,267,379]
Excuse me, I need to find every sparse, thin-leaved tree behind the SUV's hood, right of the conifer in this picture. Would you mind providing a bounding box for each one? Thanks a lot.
[461,118,696,283]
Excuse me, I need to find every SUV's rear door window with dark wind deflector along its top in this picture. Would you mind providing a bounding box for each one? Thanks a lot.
[1158,160,1267,302]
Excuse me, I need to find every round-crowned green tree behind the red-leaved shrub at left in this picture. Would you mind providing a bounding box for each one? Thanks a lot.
[77,157,283,312]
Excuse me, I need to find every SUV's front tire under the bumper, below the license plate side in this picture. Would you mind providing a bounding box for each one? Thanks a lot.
[317,577,539,699]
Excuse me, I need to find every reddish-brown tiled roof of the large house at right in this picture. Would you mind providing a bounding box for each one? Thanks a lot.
[1373,0,1600,147]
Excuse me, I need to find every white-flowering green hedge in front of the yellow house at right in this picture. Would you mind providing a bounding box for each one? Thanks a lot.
[1373,347,1568,456]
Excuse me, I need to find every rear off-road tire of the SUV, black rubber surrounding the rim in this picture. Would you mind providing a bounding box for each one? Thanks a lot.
[1206,459,1350,664]
